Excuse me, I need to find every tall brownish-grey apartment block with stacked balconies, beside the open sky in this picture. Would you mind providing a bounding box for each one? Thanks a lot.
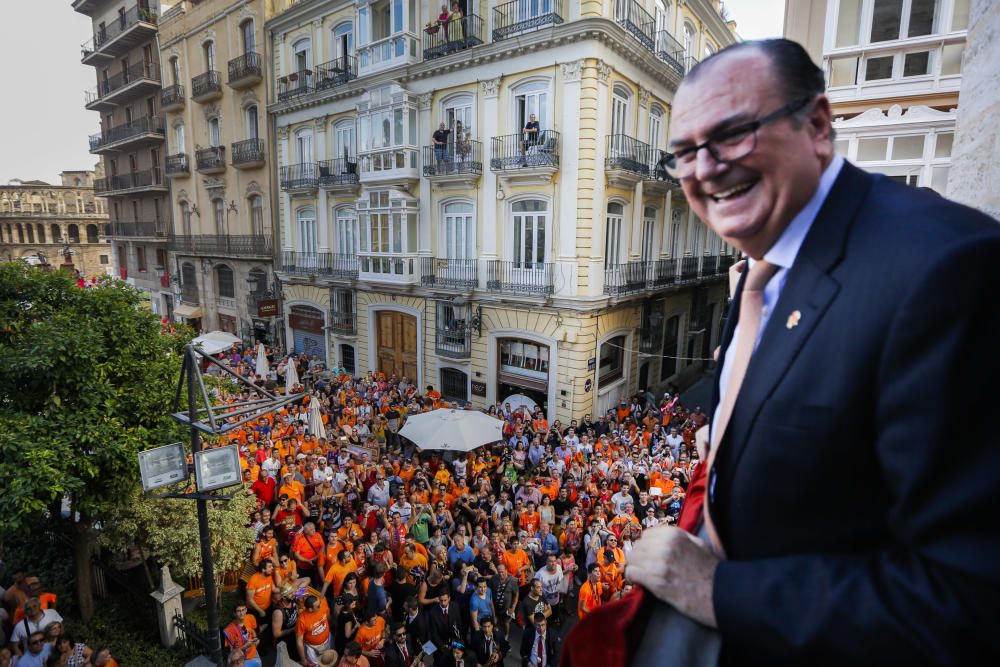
[72,0,173,316]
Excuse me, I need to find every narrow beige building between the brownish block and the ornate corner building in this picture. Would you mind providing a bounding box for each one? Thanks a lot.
[159,0,278,343]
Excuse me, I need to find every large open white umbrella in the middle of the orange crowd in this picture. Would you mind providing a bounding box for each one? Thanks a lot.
[399,408,503,452]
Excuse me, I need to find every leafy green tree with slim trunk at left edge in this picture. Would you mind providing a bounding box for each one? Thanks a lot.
[0,262,189,620]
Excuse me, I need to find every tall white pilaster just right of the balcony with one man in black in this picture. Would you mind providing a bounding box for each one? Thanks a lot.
[556,59,584,296]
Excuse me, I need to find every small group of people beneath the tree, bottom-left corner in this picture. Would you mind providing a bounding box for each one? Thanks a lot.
[0,569,118,667]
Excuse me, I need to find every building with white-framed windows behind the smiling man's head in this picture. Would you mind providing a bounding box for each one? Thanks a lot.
[784,0,971,194]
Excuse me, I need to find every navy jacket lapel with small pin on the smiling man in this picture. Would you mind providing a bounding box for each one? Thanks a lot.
[716,163,871,470]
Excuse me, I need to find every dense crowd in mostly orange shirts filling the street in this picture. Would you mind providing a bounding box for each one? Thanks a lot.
[215,349,706,667]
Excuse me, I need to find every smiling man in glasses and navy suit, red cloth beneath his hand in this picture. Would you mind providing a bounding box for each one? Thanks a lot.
[563,40,1000,666]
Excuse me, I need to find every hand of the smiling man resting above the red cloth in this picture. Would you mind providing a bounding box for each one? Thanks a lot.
[625,526,719,628]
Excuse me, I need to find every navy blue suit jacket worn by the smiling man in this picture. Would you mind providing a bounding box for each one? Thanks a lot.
[708,159,1000,667]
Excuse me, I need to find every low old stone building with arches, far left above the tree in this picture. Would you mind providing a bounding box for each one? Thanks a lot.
[0,172,112,277]
